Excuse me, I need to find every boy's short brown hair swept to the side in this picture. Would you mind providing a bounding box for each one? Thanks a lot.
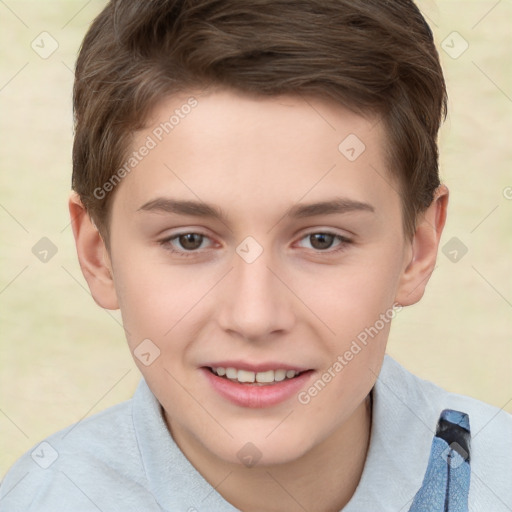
[72,0,447,246]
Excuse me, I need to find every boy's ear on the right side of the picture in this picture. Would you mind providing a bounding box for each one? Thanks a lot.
[395,185,449,306]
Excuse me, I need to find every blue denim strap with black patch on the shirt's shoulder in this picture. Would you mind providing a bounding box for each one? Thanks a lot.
[409,409,471,512]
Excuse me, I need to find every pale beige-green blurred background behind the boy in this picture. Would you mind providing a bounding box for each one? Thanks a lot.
[0,0,512,475]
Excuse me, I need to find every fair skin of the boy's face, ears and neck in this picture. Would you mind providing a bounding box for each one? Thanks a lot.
[69,90,448,512]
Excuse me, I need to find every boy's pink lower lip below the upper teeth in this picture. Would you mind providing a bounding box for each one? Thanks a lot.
[201,368,313,409]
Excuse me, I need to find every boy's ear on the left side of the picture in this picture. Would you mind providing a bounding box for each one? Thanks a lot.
[68,192,119,309]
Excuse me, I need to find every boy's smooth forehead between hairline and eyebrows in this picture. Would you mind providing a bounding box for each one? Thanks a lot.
[114,90,396,225]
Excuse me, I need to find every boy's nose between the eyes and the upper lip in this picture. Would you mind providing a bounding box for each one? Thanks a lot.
[217,246,295,341]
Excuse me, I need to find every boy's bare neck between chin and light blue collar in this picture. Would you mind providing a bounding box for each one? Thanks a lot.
[168,393,372,512]
